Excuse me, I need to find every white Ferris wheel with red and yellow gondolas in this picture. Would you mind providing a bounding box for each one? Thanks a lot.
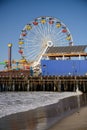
[19,16,73,65]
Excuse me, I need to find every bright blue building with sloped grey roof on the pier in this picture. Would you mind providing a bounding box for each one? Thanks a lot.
[41,45,87,76]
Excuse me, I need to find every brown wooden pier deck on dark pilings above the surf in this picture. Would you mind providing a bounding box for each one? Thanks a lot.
[0,70,87,93]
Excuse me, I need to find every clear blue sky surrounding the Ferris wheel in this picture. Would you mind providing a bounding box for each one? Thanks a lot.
[0,0,87,69]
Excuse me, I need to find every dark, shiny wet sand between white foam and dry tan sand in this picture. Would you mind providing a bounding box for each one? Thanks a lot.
[0,96,78,130]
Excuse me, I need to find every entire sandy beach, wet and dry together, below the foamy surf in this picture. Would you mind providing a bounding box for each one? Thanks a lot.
[0,95,87,130]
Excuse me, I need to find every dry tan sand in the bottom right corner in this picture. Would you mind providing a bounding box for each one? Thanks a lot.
[48,107,87,130]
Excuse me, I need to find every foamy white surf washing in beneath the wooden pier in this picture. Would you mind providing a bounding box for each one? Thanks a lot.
[0,92,77,118]
